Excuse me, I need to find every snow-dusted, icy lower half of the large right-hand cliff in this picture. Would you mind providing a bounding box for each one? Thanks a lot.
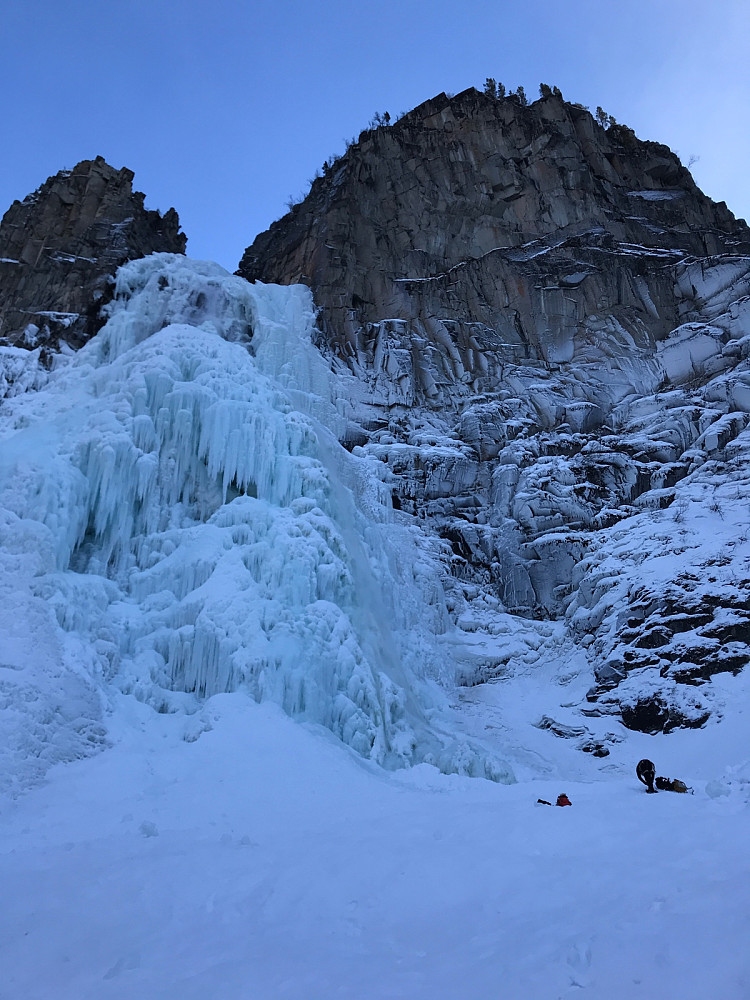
[342,257,750,732]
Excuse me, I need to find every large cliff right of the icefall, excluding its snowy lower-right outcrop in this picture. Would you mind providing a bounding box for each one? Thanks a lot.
[239,89,750,615]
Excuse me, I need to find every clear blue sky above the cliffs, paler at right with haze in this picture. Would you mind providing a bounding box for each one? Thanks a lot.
[0,0,750,270]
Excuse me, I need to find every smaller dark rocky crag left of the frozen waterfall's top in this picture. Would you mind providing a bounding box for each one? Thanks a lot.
[0,157,187,348]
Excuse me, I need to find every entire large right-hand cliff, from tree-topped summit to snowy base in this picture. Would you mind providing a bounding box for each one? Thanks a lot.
[238,89,750,732]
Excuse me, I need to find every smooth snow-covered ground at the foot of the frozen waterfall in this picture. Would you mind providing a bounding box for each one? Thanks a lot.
[0,685,750,1000]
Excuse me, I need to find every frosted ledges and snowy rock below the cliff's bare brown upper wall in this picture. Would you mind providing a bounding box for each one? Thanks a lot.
[316,236,750,732]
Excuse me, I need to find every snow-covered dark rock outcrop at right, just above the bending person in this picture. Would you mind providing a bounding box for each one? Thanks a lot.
[568,431,750,733]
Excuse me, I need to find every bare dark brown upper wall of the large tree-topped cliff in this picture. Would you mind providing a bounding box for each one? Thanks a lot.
[238,89,750,378]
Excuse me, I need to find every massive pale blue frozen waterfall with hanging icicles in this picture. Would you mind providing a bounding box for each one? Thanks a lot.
[0,254,511,780]
